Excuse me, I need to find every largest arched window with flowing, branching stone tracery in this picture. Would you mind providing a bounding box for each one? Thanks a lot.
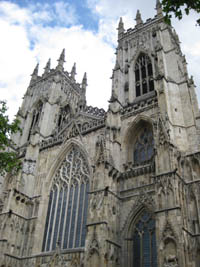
[42,145,89,251]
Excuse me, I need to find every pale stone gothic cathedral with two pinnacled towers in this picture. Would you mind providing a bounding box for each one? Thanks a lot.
[0,0,200,267]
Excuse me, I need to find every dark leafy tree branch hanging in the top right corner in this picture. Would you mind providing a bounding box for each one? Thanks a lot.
[161,0,200,26]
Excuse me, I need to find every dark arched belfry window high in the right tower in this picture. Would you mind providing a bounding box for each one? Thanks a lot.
[135,53,154,97]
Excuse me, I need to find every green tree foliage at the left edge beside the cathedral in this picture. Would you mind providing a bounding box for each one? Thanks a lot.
[0,100,21,175]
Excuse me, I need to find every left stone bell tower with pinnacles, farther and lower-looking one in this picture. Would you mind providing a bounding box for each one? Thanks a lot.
[13,49,87,195]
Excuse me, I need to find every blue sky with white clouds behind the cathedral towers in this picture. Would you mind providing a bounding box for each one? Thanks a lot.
[0,0,200,119]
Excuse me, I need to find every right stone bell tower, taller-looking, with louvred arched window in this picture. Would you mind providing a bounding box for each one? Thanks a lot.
[110,1,200,156]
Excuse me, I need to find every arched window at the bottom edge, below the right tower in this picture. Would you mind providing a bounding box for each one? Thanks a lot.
[133,211,157,267]
